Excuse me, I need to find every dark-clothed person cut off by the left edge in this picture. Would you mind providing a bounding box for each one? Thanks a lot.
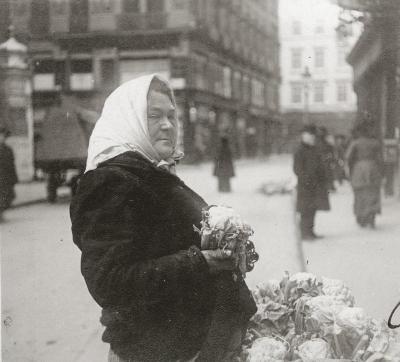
[0,127,18,221]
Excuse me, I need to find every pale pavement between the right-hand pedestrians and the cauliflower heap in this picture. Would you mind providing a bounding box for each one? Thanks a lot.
[303,183,400,319]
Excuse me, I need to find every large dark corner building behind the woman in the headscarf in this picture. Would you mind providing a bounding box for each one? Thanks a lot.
[0,0,280,161]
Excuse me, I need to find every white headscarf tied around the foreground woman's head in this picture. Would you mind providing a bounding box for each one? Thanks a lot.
[85,74,183,172]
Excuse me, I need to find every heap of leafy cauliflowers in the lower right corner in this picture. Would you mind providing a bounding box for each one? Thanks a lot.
[241,273,400,362]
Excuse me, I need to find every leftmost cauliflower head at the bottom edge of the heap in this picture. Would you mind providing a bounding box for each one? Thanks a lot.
[247,337,287,362]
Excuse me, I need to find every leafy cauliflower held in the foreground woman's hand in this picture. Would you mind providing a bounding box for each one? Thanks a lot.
[193,205,258,277]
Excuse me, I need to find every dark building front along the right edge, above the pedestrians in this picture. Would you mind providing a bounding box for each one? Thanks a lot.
[339,0,400,195]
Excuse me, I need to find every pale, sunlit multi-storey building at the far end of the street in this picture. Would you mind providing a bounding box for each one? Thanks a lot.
[279,0,358,147]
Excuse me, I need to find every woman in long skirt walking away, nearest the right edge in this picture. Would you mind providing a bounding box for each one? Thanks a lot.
[346,118,383,228]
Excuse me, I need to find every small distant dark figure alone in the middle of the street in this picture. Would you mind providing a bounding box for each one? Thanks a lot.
[214,136,235,192]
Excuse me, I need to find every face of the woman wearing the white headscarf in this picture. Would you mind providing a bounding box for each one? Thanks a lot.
[147,90,177,159]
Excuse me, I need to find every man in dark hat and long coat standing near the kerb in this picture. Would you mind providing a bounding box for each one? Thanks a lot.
[293,125,330,240]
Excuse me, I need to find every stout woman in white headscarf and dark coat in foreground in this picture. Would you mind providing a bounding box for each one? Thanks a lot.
[71,75,255,362]
